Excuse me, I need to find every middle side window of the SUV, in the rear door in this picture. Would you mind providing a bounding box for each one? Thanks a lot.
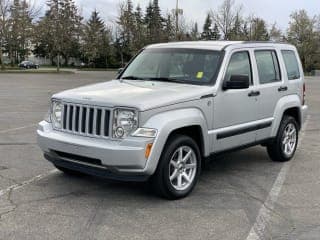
[255,50,281,84]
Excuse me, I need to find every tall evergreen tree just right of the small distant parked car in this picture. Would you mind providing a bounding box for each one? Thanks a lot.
[34,0,82,71]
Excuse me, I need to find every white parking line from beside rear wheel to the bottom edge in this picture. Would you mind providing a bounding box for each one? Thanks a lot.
[246,115,310,240]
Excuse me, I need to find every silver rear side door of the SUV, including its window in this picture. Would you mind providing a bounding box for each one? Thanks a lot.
[254,49,288,141]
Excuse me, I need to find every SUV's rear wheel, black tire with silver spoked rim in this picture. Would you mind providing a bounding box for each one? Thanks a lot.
[267,115,299,162]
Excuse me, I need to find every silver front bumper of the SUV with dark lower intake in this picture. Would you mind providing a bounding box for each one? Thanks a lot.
[37,121,154,180]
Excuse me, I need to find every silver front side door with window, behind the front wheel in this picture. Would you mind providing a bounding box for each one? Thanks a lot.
[211,50,257,152]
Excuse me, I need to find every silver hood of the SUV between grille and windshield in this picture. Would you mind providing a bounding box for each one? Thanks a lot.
[53,80,212,111]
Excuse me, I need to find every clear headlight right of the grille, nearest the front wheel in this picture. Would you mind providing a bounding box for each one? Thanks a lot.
[112,108,138,138]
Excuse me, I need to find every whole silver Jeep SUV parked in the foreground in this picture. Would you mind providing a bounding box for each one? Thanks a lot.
[37,41,307,199]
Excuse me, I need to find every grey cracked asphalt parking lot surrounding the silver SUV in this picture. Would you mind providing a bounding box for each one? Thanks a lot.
[0,72,320,240]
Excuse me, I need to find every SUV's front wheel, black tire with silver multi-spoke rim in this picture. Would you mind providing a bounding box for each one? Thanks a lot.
[151,134,201,200]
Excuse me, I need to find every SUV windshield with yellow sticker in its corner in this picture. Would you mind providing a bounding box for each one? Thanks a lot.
[121,48,222,85]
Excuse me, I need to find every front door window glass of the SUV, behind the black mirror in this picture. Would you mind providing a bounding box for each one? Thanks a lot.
[224,51,252,85]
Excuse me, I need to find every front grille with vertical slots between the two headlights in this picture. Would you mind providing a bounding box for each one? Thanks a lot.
[62,103,110,137]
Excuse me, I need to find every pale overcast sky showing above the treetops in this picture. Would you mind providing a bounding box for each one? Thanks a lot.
[41,0,320,30]
